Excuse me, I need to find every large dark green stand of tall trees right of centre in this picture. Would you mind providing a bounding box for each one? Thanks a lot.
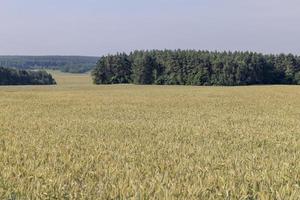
[92,50,300,86]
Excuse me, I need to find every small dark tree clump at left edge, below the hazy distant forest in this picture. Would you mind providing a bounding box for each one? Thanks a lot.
[0,67,56,85]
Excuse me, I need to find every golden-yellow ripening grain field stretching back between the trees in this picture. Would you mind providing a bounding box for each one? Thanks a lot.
[0,73,300,199]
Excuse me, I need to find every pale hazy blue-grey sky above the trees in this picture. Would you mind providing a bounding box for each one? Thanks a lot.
[0,0,300,56]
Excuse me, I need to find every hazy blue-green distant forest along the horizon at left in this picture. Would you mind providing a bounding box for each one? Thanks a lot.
[0,56,99,73]
